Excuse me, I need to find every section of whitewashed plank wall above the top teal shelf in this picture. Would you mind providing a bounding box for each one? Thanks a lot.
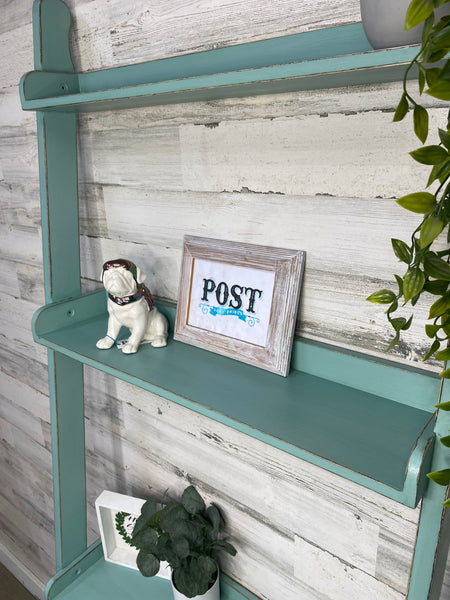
[67,0,361,70]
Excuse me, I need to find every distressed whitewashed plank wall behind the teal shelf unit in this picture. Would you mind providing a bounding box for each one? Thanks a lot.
[0,0,450,600]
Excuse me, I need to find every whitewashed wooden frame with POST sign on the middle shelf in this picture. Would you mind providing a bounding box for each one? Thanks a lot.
[174,236,305,376]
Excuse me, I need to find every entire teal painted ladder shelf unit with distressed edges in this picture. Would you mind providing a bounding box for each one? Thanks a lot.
[20,0,450,600]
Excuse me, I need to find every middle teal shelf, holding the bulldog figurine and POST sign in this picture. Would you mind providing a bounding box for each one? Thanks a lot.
[33,290,434,506]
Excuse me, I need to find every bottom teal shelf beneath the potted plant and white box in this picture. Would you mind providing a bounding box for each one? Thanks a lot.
[45,540,258,600]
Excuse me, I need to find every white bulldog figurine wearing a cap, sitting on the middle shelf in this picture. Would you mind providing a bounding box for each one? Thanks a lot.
[96,258,169,354]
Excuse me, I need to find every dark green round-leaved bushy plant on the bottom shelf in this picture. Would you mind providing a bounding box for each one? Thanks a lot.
[116,485,236,598]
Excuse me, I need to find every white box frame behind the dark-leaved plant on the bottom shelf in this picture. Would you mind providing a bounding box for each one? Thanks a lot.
[95,491,171,579]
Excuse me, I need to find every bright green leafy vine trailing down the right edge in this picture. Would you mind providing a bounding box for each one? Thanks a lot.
[368,0,450,494]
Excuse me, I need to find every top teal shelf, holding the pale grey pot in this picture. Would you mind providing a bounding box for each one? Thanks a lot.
[20,23,417,112]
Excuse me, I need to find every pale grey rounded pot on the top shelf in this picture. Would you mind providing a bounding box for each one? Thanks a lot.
[360,0,450,50]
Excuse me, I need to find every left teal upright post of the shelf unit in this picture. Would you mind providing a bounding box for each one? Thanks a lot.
[33,0,86,570]
